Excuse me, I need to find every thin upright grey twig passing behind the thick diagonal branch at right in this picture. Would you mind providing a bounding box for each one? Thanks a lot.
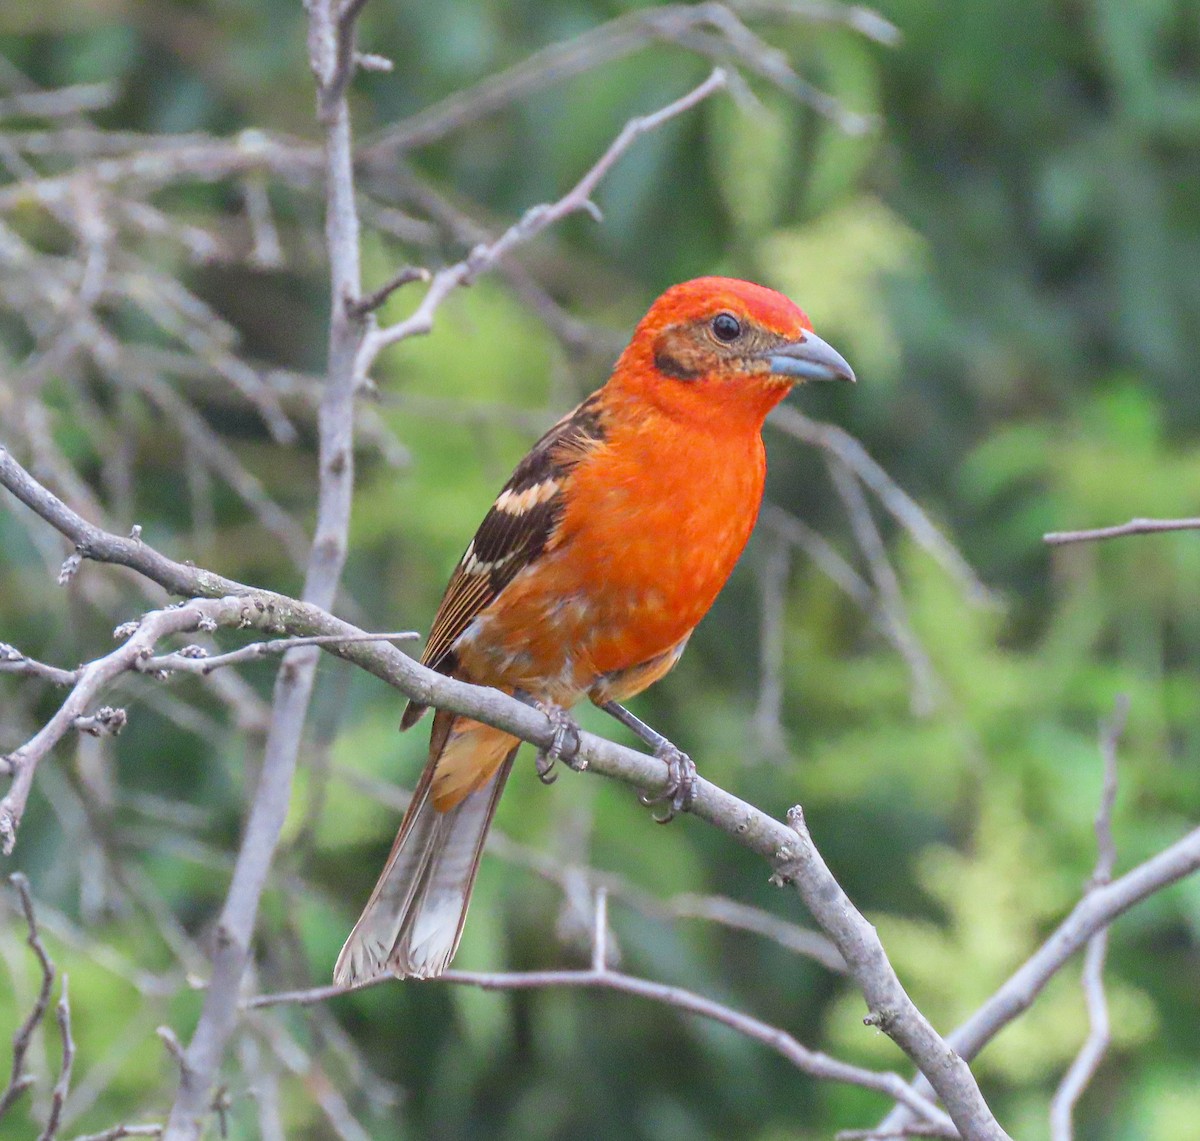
[1050,693,1129,1141]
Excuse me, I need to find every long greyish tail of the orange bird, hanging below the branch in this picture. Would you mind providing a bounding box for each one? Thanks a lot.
[334,711,520,986]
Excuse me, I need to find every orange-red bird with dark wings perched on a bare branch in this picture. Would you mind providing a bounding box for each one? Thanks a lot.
[334,276,854,986]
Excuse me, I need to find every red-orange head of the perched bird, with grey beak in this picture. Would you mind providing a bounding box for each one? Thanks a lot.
[613,277,854,424]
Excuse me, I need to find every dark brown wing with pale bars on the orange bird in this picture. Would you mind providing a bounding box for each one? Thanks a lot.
[401,392,605,728]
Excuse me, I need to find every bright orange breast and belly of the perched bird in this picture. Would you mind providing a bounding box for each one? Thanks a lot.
[461,410,766,704]
